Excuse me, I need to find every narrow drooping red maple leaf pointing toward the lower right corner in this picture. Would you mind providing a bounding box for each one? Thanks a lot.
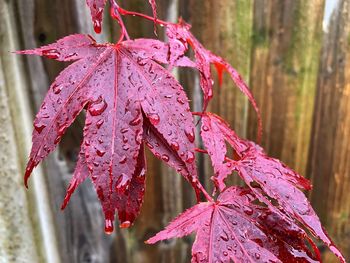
[201,113,344,260]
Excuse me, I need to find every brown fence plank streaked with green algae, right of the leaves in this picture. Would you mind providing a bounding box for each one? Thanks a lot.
[249,0,324,177]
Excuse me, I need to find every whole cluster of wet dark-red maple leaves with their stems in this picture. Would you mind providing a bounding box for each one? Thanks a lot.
[17,0,345,262]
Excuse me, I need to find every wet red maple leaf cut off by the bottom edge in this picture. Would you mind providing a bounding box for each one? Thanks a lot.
[146,187,319,263]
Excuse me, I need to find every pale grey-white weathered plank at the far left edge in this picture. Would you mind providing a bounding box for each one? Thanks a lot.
[0,0,60,263]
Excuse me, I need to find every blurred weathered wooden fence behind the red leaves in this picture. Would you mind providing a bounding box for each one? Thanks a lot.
[0,0,350,263]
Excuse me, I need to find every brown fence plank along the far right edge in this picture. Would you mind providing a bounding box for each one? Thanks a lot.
[308,0,350,262]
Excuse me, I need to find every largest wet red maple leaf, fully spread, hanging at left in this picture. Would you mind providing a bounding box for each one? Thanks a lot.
[18,35,199,232]
